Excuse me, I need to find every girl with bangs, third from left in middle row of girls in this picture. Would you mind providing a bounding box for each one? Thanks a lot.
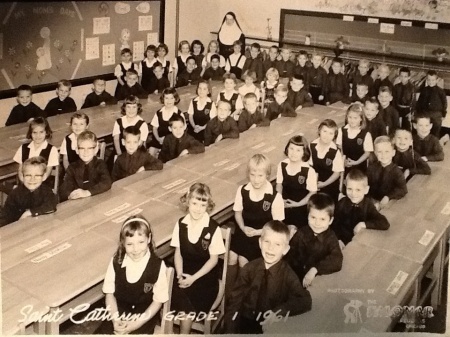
[112,95,148,156]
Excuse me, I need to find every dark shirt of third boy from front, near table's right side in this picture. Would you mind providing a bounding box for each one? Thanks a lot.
[331,196,390,245]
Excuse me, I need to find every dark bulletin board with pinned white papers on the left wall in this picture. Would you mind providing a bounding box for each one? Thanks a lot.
[0,0,164,91]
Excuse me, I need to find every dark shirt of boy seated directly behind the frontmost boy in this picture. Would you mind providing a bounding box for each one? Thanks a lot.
[285,226,343,282]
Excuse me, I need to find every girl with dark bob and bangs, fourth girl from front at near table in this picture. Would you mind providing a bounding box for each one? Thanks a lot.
[276,135,317,228]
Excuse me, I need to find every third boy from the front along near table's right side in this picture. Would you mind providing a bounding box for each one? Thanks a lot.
[332,169,390,247]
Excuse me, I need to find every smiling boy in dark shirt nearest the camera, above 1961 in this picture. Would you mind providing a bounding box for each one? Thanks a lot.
[224,220,312,334]
